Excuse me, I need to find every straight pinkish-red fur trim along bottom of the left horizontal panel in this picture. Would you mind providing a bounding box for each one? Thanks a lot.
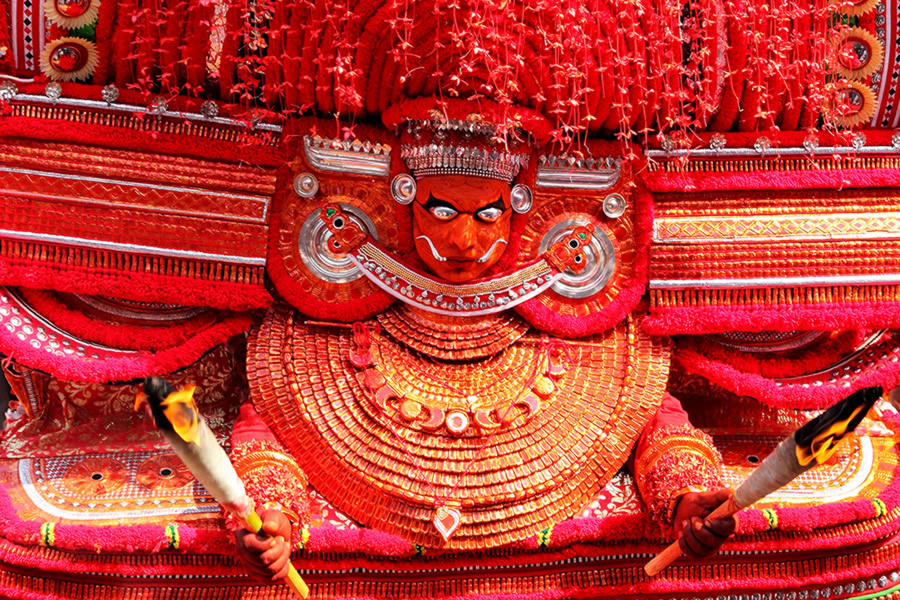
[0,258,272,311]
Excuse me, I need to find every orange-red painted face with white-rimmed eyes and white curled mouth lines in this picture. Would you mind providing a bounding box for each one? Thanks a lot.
[413,175,512,283]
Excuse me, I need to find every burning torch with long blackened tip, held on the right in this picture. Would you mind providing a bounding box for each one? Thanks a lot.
[644,387,882,577]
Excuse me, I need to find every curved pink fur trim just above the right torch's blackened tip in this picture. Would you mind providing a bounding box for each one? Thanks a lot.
[673,350,900,408]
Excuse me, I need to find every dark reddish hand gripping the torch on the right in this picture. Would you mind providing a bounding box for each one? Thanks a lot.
[675,488,737,558]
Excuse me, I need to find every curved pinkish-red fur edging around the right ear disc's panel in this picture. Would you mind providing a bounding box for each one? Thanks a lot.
[515,190,653,338]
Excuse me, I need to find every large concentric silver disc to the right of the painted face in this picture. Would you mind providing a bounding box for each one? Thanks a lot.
[538,219,616,298]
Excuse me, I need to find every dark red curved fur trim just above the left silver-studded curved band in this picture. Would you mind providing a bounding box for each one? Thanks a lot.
[19,288,250,351]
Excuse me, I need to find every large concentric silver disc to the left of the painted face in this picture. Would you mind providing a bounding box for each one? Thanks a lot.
[297,203,378,283]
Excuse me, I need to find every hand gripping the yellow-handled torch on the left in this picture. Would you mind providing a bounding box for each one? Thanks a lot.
[234,508,291,583]
